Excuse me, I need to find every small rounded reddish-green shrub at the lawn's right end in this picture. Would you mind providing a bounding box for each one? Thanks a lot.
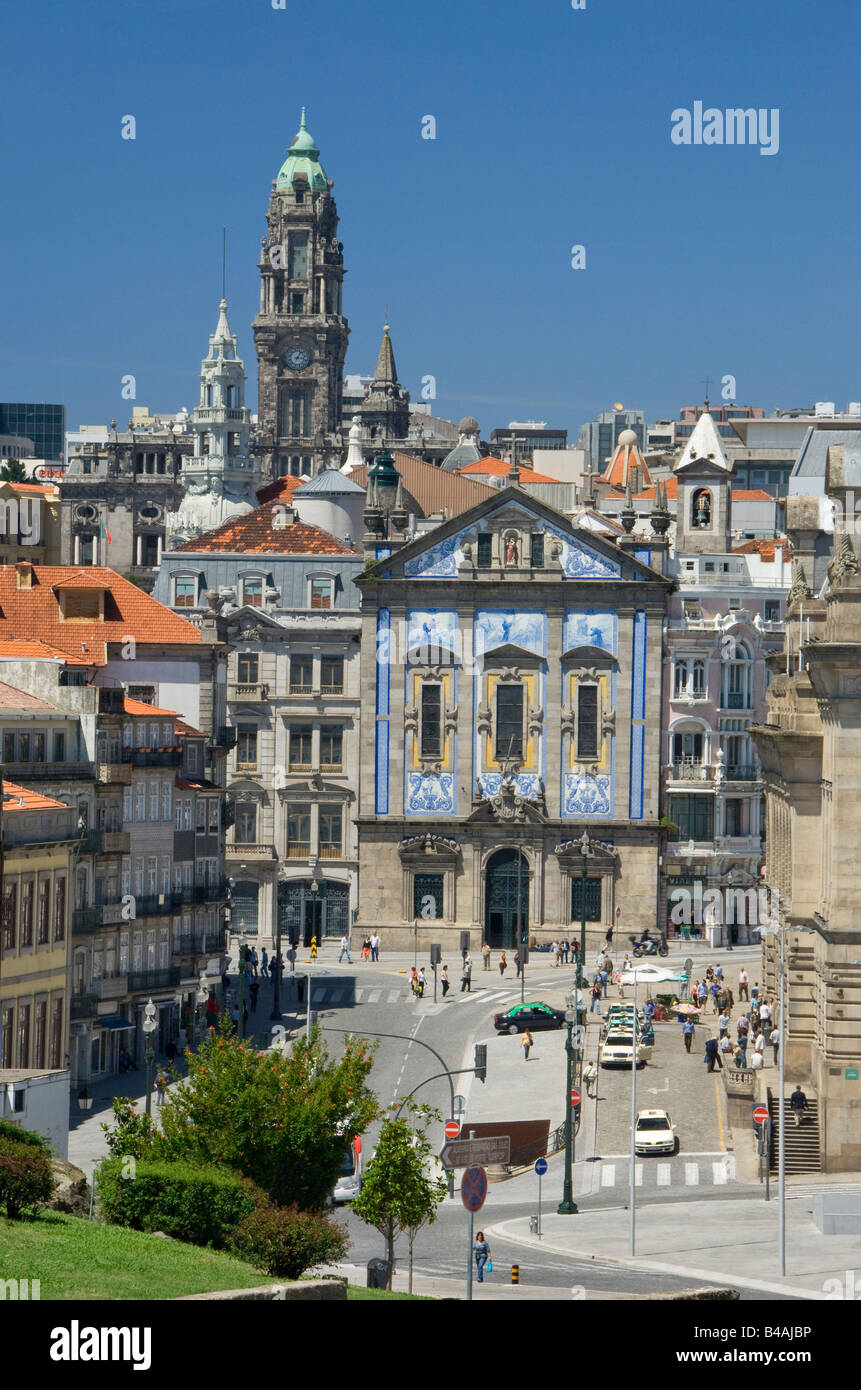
[230,1205,349,1279]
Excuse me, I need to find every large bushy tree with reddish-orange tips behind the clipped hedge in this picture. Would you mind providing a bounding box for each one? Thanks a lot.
[148,1017,378,1211]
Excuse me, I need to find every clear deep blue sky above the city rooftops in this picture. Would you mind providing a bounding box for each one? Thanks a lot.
[0,0,861,436]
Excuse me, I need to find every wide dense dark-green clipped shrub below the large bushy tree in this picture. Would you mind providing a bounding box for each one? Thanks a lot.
[97,1158,263,1248]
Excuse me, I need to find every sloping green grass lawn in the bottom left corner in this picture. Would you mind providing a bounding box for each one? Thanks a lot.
[0,1211,274,1300]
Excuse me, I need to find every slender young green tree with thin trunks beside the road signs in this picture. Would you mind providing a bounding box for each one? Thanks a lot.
[353,1105,446,1293]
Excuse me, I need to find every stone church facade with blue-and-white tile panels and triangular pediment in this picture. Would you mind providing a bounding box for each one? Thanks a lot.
[356,487,670,949]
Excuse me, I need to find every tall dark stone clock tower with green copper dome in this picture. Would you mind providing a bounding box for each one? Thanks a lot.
[253,107,349,478]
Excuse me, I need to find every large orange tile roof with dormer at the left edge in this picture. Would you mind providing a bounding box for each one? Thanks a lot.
[0,564,200,666]
